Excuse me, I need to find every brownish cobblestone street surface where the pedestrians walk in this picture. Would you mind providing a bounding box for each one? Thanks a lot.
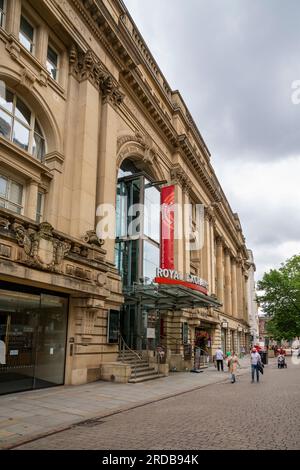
[19,361,300,450]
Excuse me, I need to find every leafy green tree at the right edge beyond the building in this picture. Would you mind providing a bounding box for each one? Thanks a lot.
[257,255,300,340]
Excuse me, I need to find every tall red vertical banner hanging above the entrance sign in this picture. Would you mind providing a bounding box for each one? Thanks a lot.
[160,185,175,269]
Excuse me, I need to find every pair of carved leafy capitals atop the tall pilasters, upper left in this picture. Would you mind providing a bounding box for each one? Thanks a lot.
[69,44,124,105]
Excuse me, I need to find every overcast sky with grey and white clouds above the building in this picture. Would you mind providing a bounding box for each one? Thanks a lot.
[125,0,300,280]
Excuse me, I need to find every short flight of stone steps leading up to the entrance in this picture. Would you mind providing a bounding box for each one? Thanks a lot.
[118,350,164,383]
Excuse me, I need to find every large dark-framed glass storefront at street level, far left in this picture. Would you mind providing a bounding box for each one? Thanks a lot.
[0,286,68,394]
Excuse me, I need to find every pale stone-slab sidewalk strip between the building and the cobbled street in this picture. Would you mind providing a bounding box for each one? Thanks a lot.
[0,358,250,449]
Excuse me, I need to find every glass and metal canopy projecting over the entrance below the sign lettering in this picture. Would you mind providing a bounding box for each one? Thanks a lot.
[124,283,222,310]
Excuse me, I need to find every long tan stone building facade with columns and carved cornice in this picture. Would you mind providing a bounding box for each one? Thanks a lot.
[0,0,253,393]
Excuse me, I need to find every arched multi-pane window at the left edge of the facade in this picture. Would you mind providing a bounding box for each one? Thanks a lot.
[0,86,45,161]
